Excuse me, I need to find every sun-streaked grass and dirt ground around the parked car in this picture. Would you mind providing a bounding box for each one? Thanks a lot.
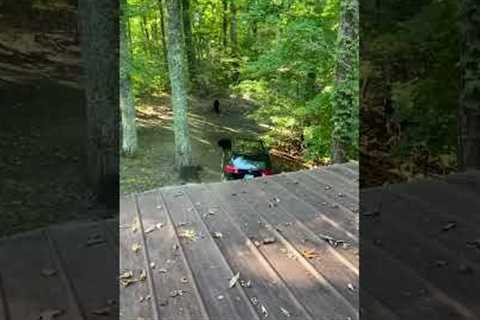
[120,94,302,194]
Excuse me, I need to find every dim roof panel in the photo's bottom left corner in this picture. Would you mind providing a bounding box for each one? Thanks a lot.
[0,230,83,320]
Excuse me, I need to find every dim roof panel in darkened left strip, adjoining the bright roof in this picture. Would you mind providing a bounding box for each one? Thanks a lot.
[48,222,118,319]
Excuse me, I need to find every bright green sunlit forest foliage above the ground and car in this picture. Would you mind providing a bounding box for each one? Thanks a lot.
[124,0,358,163]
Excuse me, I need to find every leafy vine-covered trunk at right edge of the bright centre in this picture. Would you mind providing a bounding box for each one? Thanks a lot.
[332,0,359,163]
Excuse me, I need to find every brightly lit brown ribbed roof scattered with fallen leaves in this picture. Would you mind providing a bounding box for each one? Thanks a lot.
[120,163,359,320]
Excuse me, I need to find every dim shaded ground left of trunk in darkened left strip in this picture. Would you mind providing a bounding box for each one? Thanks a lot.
[0,81,112,236]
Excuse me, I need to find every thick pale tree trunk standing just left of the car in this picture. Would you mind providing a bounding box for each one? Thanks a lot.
[166,0,192,171]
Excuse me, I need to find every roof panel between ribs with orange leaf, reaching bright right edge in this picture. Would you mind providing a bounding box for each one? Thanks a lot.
[227,179,358,309]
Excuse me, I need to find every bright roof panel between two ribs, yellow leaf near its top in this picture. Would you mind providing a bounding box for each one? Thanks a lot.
[161,188,260,320]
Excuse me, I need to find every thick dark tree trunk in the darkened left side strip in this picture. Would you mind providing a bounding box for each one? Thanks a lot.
[78,0,119,205]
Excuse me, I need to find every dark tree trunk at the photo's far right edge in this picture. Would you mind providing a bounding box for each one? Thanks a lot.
[459,0,480,169]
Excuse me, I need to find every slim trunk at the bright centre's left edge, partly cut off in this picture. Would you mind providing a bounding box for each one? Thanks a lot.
[120,0,138,156]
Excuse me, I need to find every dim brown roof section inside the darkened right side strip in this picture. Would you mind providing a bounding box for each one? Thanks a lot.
[360,171,480,320]
